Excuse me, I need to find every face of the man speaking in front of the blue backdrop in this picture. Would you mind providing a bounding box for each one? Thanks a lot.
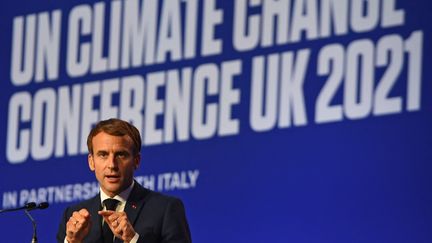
[88,132,140,197]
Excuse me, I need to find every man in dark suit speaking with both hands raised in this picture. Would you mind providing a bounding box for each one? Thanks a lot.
[57,119,191,243]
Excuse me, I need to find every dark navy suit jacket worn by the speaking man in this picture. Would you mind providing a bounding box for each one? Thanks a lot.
[57,182,192,243]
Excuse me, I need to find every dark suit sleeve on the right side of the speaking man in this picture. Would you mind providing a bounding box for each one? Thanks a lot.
[161,198,192,243]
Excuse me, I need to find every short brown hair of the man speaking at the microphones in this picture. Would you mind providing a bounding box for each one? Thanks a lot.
[87,118,141,155]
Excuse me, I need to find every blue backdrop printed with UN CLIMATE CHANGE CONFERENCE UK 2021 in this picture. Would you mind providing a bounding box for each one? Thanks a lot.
[0,0,432,243]
